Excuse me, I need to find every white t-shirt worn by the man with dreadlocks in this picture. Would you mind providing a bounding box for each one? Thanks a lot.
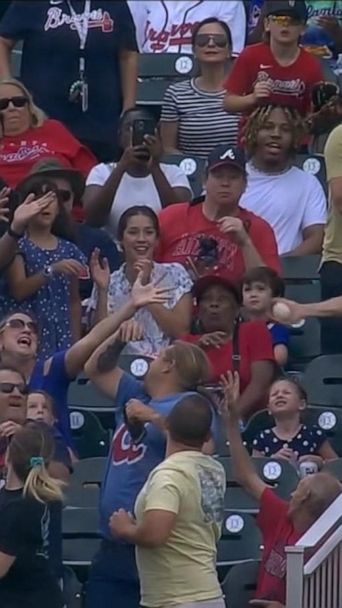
[241,163,327,255]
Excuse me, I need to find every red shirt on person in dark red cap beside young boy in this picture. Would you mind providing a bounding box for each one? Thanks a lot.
[181,321,274,384]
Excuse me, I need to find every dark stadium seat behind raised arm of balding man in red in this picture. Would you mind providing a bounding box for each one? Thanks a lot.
[219,458,298,513]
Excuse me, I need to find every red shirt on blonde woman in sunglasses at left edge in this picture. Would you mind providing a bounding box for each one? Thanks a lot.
[0,119,97,188]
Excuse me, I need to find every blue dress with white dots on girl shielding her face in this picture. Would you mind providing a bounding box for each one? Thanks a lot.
[8,237,87,358]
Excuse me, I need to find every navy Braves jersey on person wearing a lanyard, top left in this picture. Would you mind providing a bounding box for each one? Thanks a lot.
[0,0,137,143]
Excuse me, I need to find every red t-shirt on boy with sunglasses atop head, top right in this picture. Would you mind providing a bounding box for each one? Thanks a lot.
[225,42,324,115]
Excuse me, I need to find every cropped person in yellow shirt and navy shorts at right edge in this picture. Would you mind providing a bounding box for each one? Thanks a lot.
[321,124,342,354]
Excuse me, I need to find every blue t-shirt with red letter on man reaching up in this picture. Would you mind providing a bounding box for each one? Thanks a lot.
[100,373,216,540]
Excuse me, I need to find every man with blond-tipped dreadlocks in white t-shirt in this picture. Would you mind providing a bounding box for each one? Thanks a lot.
[241,105,327,256]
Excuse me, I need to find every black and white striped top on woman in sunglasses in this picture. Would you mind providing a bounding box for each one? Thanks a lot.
[161,79,239,158]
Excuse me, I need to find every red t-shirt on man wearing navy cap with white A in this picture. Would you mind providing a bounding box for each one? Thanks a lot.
[157,203,280,281]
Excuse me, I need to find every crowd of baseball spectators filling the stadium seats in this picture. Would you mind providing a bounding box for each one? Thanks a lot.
[0,0,342,608]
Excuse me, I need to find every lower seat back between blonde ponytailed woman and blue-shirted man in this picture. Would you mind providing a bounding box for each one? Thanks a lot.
[62,508,101,568]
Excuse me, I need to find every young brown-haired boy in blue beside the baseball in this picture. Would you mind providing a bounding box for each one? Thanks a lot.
[242,266,290,367]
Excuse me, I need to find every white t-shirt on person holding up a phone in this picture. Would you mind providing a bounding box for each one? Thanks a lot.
[86,163,191,238]
